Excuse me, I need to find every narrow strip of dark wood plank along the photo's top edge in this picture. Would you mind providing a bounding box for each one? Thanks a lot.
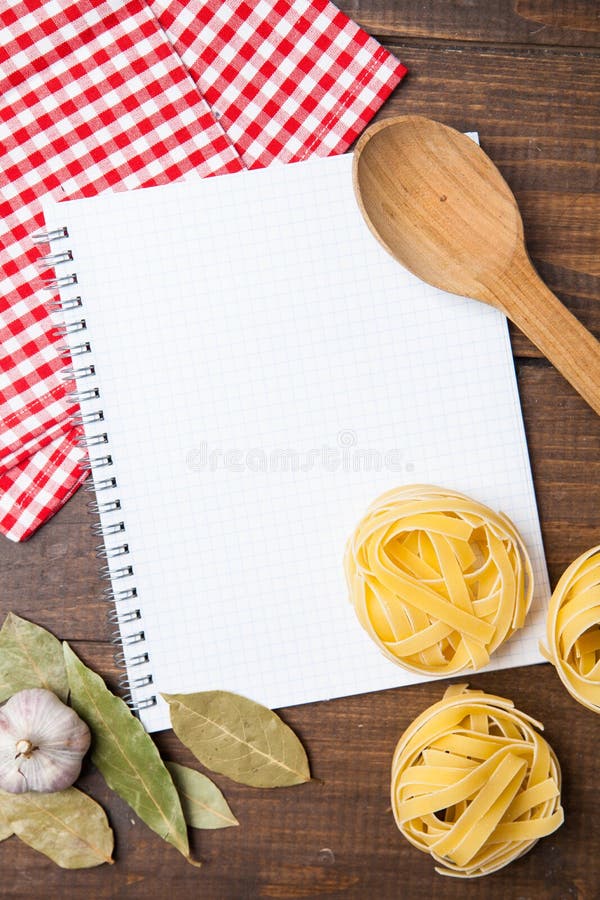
[337,0,600,47]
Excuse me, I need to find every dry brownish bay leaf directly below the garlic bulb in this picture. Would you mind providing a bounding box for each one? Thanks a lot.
[0,787,114,869]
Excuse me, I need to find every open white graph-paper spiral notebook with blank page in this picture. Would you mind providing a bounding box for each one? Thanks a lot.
[39,156,549,731]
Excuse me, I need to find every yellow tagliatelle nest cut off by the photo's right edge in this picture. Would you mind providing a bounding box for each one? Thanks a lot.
[540,546,600,713]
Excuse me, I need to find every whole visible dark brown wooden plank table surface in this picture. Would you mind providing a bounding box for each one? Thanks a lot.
[0,0,600,900]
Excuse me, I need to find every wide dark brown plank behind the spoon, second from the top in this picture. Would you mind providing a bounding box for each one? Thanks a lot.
[370,41,600,356]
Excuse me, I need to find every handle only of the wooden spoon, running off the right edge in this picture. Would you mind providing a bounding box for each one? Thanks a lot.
[482,257,600,415]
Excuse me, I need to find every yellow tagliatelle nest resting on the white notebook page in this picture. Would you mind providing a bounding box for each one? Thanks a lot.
[344,485,533,676]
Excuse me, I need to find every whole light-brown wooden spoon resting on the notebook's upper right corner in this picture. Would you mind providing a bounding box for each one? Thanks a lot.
[353,116,600,414]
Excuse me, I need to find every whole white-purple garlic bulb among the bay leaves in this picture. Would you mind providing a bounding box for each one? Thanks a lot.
[0,688,91,794]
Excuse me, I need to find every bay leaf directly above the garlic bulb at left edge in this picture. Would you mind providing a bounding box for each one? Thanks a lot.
[0,613,69,703]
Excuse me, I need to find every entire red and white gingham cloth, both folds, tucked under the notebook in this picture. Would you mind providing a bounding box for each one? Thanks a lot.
[0,0,405,540]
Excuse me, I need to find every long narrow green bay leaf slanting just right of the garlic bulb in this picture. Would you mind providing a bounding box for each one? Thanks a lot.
[63,642,192,862]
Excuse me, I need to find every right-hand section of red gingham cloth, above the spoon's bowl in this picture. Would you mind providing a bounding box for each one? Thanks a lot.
[150,0,406,168]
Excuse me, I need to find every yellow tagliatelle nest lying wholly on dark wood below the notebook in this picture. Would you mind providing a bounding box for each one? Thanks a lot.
[391,685,564,878]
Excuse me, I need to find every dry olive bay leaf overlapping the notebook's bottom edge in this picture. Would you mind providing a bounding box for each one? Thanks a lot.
[163,691,310,787]
